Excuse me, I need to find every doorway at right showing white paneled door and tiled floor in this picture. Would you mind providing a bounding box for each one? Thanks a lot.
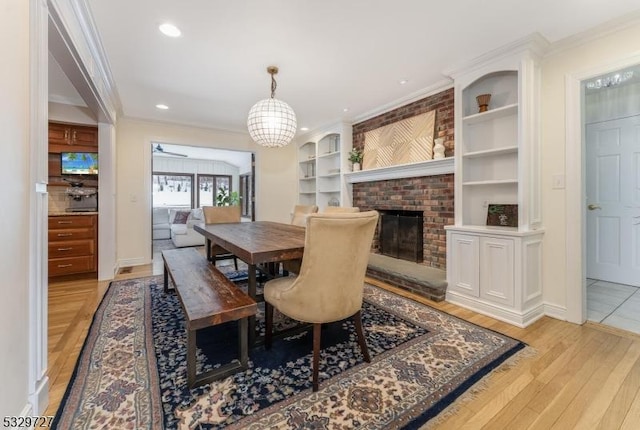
[583,67,640,333]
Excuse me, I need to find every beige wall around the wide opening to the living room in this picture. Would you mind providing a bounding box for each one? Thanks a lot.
[116,119,296,266]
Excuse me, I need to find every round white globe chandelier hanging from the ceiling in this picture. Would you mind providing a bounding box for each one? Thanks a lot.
[247,66,297,148]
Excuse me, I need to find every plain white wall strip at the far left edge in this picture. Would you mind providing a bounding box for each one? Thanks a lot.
[0,0,31,417]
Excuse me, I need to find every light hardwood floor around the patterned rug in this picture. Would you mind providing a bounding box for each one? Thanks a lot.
[46,264,640,430]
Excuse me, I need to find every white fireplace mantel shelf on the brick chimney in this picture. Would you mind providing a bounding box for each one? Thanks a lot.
[344,157,454,184]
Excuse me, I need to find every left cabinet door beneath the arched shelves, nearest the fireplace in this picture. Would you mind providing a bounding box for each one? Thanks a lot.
[447,233,479,297]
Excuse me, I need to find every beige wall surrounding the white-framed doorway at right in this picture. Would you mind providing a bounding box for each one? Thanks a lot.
[540,23,640,307]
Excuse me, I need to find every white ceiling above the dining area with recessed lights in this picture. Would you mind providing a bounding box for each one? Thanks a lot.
[54,0,640,131]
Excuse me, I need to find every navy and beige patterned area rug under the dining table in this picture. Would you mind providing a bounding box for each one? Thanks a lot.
[54,277,524,429]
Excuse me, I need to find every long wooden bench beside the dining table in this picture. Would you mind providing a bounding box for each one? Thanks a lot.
[162,248,257,388]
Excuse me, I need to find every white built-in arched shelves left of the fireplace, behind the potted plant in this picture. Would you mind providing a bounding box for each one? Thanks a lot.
[297,123,352,211]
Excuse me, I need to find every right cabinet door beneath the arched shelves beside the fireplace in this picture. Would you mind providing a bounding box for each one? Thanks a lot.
[480,237,515,306]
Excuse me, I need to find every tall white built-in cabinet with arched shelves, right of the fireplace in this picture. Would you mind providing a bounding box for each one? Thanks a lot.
[446,36,546,327]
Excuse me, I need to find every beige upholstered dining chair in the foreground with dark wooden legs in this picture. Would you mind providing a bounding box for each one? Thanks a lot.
[264,211,378,391]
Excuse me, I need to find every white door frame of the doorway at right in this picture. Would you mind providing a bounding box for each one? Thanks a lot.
[565,55,640,324]
